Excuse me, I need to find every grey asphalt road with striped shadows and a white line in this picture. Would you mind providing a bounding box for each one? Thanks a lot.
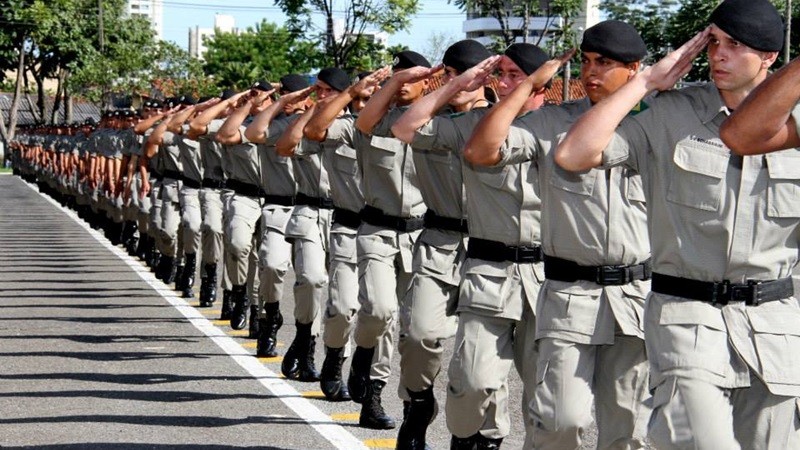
[0,175,536,450]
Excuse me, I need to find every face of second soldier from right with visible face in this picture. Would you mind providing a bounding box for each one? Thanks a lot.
[581,52,639,103]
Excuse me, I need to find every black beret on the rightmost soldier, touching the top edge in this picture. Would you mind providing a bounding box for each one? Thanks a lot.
[709,0,784,52]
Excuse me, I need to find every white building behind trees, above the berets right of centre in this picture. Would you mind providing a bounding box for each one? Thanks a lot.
[463,0,600,45]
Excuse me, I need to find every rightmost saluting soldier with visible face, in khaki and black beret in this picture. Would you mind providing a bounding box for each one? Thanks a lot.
[555,0,800,449]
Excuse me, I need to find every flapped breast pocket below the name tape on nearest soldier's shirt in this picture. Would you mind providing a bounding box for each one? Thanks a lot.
[667,139,730,211]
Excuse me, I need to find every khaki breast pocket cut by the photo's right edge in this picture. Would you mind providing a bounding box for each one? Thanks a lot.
[766,150,800,218]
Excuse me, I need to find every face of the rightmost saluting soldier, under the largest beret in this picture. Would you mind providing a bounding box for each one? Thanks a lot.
[708,25,778,94]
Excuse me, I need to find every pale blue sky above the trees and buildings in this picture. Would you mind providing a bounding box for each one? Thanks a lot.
[162,0,466,52]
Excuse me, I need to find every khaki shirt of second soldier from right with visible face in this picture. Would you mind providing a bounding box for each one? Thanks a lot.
[500,98,650,345]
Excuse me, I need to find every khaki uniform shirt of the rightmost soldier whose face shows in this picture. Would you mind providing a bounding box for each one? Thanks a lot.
[603,84,800,396]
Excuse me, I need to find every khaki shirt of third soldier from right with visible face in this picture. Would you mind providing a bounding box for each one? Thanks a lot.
[412,109,544,320]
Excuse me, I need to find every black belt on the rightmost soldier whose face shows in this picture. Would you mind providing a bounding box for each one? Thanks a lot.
[652,273,794,306]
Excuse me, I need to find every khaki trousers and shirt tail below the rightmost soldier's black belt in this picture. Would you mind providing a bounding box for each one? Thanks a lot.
[645,293,800,450]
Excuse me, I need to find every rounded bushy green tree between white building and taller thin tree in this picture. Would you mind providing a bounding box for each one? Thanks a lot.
[203,21,321,89]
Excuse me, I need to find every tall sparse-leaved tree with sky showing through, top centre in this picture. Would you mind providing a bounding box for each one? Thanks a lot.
[275,0,419,68]
